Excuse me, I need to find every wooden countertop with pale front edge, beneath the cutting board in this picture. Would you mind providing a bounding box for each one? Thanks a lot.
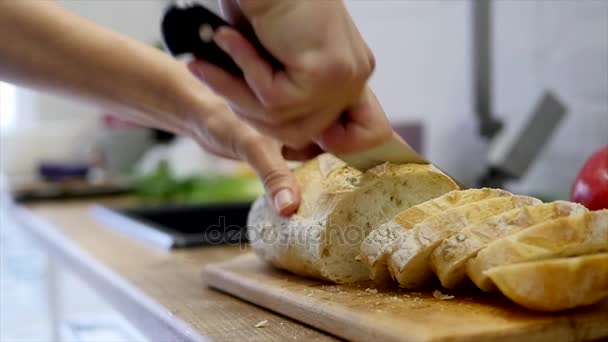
[15,201,335,341]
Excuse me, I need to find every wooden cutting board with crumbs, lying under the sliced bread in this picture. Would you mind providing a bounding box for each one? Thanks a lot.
[205,253,608,342]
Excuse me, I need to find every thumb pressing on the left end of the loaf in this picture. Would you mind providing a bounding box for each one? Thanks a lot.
[240,134,301,216]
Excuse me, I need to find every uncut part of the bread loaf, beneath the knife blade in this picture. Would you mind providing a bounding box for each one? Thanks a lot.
[248,154,458,283]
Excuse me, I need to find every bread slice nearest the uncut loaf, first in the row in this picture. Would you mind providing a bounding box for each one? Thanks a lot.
[361,188,513,283]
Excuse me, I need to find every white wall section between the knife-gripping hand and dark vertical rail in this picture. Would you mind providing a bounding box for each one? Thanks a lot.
[348,0,484,187]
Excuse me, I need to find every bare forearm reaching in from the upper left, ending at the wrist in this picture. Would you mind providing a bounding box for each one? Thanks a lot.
[0,0,220,133]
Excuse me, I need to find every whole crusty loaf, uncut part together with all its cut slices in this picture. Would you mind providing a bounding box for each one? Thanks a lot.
[248,154,608,311]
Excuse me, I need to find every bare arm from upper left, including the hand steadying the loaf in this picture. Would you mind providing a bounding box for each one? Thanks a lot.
[0,0,300,215]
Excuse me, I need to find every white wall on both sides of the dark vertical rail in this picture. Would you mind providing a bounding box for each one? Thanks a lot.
[348,0,608,196]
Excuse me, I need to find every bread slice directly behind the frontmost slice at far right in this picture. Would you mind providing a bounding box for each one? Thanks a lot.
[466,209,608,292]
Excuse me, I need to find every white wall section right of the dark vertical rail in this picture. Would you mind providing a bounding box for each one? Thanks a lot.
[496,0,608,195]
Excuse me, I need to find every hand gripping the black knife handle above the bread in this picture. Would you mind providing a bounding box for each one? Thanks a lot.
[189,0,391,153]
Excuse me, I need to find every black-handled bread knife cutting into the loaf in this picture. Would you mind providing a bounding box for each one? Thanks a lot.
[161,2,429,171]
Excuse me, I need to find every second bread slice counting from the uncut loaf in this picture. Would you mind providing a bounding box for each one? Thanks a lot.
[388,196,541,289]
